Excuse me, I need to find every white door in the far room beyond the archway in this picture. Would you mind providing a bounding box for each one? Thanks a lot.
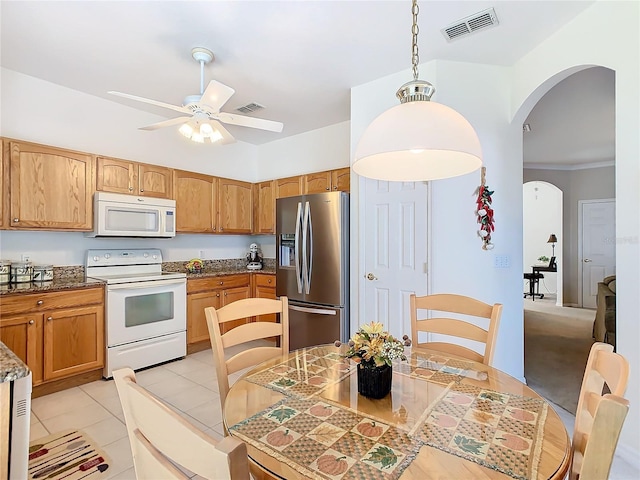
[579,200,616,308]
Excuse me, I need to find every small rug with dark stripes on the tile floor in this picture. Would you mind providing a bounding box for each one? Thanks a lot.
[29,430,110,480]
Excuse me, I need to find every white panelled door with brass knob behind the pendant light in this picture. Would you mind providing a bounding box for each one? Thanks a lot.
[359,179,428,336]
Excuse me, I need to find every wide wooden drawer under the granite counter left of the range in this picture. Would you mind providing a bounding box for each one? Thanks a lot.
[0,287,104,315]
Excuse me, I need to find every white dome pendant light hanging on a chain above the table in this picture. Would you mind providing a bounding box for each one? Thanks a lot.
[353,0,482,181]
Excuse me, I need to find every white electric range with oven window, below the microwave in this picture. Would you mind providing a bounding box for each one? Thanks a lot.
[85,248,187,378]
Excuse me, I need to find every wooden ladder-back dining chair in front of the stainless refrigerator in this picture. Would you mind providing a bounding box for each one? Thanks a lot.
[204,297,289,410]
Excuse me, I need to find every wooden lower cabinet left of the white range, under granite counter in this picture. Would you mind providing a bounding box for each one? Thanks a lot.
[0,287,104,386]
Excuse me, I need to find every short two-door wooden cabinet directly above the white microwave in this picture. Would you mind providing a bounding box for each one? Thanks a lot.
[96,157,173,198]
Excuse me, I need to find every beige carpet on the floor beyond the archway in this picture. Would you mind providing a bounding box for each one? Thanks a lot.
[524,298,595,415]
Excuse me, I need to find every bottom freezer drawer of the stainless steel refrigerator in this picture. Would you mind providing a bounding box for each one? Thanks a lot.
[289,303,348,351]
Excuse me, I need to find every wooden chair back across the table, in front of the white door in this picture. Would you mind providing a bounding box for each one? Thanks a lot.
[410,294,502,365]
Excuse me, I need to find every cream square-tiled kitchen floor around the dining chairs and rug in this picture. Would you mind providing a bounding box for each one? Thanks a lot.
[31,350,640,480]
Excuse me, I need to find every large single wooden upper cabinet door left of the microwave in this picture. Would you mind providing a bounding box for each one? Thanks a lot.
[10,142,93,230]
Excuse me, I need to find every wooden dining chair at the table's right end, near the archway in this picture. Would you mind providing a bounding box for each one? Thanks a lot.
[569,342,629,480]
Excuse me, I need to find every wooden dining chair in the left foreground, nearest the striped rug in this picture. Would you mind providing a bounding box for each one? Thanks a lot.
[113,368,250,480]
